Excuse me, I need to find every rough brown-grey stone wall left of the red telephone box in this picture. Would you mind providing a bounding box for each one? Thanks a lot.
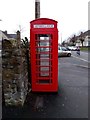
[2,36,28,106]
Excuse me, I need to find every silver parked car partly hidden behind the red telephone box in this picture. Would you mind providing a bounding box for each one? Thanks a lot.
[58,47,71,57]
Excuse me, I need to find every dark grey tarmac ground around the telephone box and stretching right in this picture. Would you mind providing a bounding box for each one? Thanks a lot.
[3,53,89,118]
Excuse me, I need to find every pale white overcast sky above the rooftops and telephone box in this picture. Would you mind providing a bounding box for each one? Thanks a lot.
[0,0,89,43]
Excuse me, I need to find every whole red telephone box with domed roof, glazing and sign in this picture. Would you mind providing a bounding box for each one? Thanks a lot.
[30,18,58,92]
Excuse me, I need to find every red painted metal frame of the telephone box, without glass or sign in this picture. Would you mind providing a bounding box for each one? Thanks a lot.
[30,18,58,92]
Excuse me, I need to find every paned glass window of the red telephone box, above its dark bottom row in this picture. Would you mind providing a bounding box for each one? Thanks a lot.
[36,34,52,77]
